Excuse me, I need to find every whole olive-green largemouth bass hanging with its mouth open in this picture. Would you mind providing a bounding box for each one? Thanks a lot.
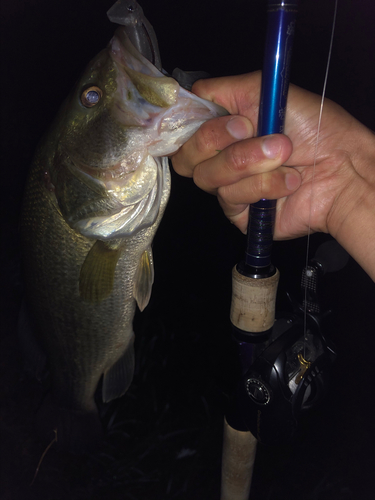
[21,3,225,452]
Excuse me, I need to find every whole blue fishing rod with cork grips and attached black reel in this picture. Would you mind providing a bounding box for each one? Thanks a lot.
[221,0,348,500]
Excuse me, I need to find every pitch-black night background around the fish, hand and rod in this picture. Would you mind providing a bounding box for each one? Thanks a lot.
[0,0,375,500]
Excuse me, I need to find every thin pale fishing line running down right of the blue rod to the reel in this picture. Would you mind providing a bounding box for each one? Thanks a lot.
[303,0,338,352]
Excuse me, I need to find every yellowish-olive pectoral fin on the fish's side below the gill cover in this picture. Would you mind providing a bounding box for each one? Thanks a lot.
[79,240,121,302]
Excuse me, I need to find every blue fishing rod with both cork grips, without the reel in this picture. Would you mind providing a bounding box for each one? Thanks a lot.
[221,1,297,500]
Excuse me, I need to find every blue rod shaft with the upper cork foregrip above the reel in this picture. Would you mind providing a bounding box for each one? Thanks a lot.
[231,0,297,344]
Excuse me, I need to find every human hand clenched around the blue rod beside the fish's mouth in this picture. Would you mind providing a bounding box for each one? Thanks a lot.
[172,72,375,250]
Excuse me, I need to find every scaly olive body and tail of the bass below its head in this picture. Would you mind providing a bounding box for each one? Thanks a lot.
[21,157,167,451]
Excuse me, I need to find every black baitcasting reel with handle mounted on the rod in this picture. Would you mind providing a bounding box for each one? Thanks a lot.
[227,241,348,444]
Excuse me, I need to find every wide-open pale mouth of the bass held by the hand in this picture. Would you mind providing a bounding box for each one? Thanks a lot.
[109,27,228,156]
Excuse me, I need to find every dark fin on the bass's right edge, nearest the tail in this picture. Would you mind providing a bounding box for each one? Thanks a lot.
[102,334,135,403]
